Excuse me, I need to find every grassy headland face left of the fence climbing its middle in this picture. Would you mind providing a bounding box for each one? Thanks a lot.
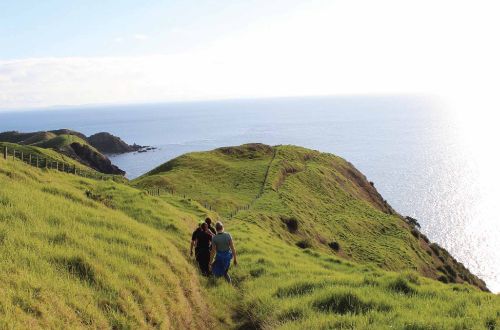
[137,147,273,211]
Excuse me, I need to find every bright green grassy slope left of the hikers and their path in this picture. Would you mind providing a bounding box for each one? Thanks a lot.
[0,159,221,328]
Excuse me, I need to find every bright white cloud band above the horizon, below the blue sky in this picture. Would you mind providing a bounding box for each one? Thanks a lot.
[0,0,500,108]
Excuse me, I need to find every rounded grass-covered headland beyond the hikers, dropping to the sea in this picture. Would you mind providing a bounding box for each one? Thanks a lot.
[134,144,485,288]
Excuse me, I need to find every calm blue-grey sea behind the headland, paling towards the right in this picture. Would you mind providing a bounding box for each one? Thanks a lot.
[0,97,500,292]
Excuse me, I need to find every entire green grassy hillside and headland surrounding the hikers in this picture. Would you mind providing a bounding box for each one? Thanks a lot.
[0,145,500,329]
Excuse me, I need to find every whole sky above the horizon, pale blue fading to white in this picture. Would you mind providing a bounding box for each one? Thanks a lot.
[0,0,500,114]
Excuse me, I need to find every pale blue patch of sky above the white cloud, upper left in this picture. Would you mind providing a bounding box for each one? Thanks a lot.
[0,0,297,60]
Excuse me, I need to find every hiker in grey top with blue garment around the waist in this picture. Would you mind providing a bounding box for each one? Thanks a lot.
[210,221,238,283]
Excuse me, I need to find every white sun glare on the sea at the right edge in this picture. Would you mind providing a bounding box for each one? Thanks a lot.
[447,94,500,292]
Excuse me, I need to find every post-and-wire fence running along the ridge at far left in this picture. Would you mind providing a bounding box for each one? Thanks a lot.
[1,146,110,180]
